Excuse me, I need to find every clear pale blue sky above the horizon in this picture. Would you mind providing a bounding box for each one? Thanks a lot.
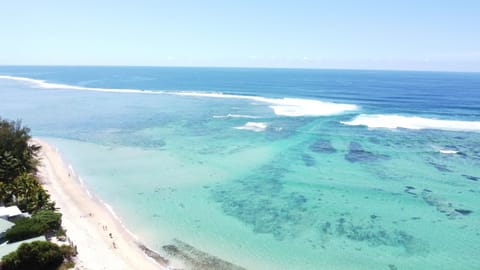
[0,0,480,71]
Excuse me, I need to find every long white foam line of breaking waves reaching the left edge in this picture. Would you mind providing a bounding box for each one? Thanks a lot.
[0,75,359,117]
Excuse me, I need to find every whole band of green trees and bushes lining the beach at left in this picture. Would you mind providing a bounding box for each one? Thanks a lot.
[0,118,76,270]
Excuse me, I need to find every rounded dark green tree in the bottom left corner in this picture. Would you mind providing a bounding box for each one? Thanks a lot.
[1,241,63,270]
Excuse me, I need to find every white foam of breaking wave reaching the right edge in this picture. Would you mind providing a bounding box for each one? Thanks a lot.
[341,114,480,132]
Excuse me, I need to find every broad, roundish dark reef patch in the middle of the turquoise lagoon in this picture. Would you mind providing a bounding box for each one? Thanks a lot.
[211,163,308,240]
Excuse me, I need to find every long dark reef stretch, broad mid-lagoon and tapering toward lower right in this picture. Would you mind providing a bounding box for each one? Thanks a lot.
[210,163,427,254]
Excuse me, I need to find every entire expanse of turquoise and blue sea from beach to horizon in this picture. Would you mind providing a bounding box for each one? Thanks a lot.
[0,67,480,270]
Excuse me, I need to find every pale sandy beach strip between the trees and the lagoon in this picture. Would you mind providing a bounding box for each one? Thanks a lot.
[32,139,167,270]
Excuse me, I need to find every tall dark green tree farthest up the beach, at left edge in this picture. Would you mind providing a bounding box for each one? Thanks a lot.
[0,118,40,182]
